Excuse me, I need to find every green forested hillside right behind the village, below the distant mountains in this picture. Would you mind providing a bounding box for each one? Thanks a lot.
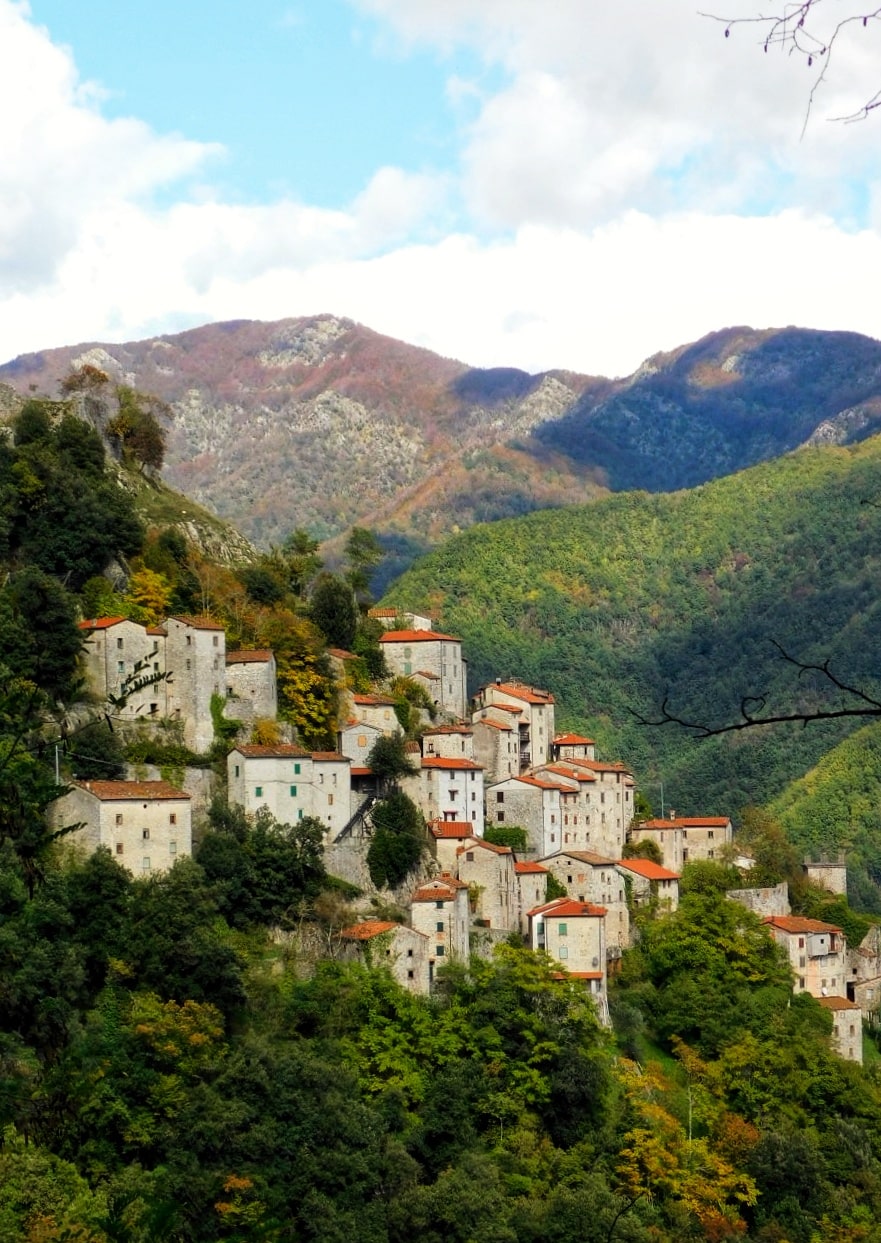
[386,438,881,814]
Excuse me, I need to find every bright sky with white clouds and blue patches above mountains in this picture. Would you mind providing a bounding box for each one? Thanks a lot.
[0,0,881,375]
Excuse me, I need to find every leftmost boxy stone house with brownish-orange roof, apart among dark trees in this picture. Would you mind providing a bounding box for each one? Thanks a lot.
[56,781,193,876]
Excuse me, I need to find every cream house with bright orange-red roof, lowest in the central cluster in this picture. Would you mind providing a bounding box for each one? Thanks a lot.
[528,897,609,1025]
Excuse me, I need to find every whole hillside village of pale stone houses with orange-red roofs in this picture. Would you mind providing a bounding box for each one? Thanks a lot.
[53,608,881,1062]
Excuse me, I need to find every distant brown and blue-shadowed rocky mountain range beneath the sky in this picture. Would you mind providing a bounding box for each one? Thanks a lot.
[6,316,881,574]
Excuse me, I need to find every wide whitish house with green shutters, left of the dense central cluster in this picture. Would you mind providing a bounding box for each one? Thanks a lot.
[226,742,352,840]
